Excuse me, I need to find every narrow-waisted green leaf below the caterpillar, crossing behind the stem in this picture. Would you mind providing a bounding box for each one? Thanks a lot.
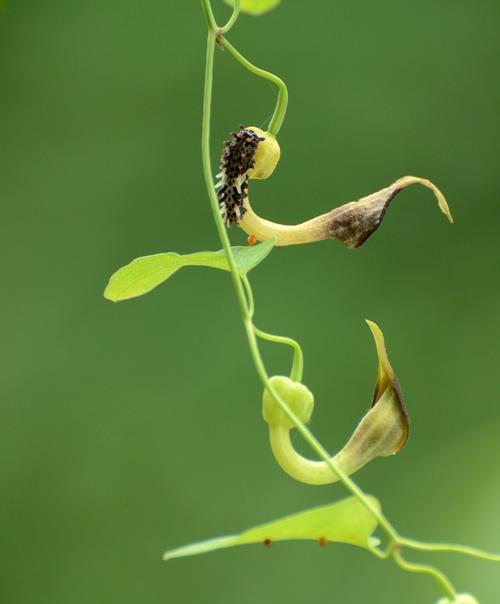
[104,239,274,302]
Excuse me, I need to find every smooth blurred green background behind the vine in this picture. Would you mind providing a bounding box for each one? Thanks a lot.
[0,0,500,604]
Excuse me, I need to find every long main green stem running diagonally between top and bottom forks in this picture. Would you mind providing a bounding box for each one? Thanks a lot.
[202,0,398,541]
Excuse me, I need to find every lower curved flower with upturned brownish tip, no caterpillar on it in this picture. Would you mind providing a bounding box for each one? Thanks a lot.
[263,321,409,485]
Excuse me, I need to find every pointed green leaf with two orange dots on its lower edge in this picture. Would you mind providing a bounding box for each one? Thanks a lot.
[163,497,380,560]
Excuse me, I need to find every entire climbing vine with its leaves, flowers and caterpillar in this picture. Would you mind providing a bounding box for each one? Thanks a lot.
[105,0,500,604]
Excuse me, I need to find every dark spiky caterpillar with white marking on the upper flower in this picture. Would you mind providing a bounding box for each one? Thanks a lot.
[216,126,264,227]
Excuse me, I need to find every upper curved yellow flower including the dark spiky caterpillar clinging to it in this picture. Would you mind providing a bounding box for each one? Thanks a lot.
[216,126,453,248]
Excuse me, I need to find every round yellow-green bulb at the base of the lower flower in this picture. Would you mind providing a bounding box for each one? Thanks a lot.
[262,375,314,430]
